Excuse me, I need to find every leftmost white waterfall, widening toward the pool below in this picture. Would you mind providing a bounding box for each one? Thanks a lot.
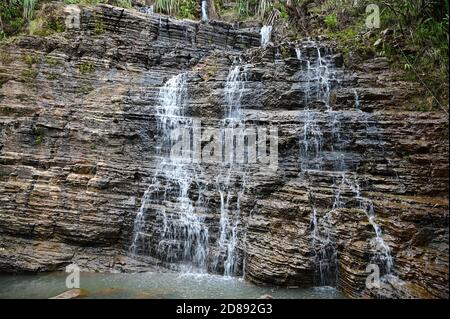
[131,73,209,271]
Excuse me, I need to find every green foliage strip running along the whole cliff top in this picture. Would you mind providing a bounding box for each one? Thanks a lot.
[0,0,449,109]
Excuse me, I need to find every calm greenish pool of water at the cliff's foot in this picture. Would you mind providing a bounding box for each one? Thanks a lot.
[0,272,345,299]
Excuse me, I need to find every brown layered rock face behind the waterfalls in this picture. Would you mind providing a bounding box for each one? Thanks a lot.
[0,5,449,298]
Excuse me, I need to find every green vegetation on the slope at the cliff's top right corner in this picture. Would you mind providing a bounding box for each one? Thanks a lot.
[307,0,449,110]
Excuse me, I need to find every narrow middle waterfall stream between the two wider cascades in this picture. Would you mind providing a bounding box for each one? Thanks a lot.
[215,64,247,276]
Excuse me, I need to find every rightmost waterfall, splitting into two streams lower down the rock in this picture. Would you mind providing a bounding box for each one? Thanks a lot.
[295,41,393,286]
